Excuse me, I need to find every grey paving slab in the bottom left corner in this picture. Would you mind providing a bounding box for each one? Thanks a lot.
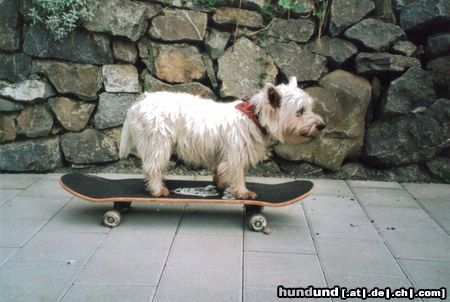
[0,263,80,302]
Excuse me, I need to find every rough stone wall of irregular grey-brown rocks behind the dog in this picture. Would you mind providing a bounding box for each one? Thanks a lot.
[0,0,450,182]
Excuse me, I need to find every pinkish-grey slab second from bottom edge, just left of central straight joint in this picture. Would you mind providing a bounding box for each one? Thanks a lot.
[167,235,242,270]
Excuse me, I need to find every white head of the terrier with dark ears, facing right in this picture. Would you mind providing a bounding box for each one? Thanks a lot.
[255,77,325,143]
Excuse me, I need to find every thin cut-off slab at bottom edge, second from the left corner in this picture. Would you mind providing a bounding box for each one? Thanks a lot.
[62,283,155,302]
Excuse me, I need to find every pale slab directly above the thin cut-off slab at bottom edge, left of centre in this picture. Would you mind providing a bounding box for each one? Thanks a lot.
[77,246,167,286]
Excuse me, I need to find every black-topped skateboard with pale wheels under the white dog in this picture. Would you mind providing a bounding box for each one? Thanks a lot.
[60,173,314,233]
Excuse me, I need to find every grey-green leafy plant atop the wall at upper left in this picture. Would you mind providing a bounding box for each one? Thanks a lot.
[28,0,92,41]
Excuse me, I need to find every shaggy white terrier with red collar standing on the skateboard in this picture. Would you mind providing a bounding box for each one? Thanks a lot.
[120,78,325,199]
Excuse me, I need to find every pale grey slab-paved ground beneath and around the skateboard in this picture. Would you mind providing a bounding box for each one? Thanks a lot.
[0,174,450,302]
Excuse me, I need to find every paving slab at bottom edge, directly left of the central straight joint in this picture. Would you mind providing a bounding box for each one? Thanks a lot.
[153,266,242,302]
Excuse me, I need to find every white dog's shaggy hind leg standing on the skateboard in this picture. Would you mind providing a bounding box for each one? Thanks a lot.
[136,136,172,197]
